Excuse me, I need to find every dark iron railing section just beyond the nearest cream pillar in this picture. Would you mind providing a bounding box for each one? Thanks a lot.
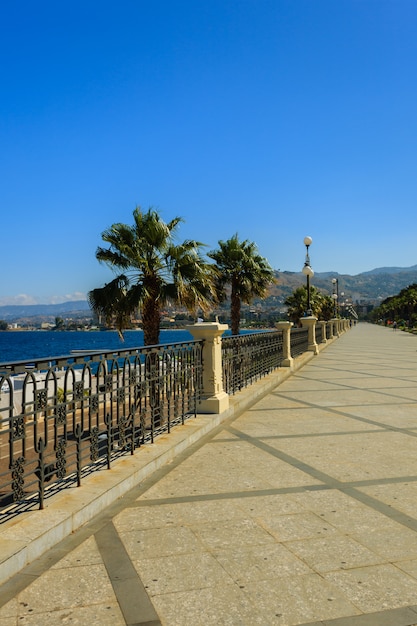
[222,330,283,394]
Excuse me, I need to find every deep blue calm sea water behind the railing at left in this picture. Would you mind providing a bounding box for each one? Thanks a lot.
[0,330,192,363]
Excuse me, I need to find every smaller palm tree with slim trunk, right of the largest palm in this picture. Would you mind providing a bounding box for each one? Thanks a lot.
[208,234,275,335]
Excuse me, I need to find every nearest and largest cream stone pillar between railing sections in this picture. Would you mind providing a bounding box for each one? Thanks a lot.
[186,322,229,413]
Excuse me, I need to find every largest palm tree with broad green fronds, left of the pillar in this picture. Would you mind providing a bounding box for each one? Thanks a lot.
[88,207,215,345]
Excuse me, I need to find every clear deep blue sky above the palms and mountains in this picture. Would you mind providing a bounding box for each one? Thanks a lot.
[0,0,417,304]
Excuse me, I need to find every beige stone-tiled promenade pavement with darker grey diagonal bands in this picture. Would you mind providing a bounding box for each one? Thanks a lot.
[0,323,417,626]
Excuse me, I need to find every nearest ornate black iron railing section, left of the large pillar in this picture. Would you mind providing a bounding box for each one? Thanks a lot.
[0,341,202,518]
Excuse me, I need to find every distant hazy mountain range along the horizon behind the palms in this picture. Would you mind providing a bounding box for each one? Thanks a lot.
[0,265,417,323]
